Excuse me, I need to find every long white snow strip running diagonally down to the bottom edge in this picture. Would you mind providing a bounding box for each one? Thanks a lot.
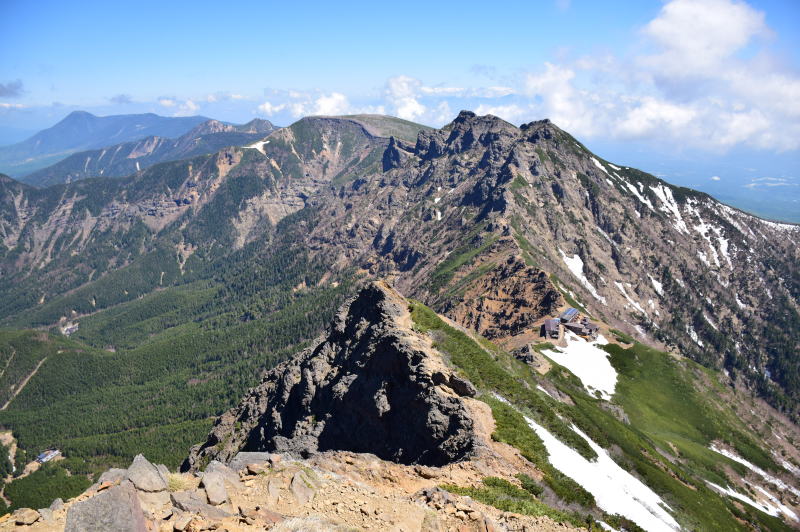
[525,417,680,532]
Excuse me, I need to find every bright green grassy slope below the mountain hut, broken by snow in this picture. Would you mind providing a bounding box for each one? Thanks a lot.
[410,302,790,532]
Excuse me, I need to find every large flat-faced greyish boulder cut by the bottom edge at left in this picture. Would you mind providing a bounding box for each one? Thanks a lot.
[64,485,147,532]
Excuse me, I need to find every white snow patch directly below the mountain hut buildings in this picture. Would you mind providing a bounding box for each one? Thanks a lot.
[542,331,617,401]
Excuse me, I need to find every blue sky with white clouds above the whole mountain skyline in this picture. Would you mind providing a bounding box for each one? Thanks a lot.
[0,0,800,218]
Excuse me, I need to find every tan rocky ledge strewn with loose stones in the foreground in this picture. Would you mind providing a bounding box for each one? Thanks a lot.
[0,452,584,532]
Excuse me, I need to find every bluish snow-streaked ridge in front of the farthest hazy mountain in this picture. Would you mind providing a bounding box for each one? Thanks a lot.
[21,119,275,187]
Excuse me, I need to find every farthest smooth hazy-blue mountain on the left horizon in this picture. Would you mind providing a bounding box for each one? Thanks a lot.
[0,111,208,177]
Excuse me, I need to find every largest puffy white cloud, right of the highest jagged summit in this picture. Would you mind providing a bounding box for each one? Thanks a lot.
[468,0,800,151]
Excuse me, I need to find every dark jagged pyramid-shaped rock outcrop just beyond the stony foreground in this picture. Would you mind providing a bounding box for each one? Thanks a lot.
[183,282,476,469]
